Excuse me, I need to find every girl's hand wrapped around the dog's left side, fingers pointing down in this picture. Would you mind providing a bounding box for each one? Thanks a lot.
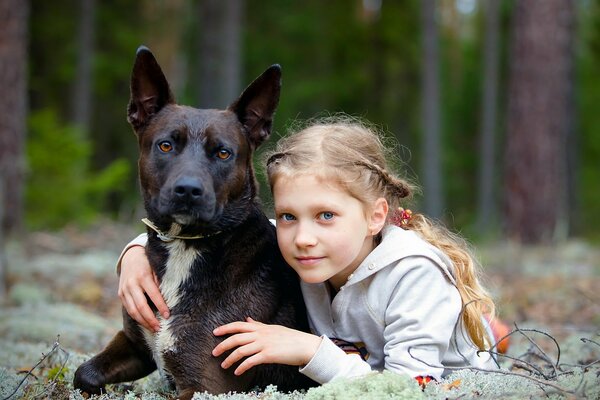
[119,246,169,332]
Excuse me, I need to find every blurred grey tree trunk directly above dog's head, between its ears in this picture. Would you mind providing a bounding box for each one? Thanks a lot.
[198,0,243,108]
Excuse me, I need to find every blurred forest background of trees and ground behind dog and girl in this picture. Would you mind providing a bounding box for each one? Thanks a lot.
[0,0,600,398]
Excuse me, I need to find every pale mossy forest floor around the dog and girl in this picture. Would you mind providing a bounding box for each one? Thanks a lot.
[0,223,600,400]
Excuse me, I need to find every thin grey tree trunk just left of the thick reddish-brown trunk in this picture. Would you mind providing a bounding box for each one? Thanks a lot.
[477,0,499,232]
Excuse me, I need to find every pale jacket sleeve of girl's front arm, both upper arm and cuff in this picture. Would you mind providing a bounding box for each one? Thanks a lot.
[300,257,461,384]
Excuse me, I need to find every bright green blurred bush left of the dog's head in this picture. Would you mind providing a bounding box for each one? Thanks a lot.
[26,110,130,228]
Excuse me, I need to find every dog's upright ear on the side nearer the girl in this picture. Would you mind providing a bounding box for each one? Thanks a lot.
[228,64,281,148]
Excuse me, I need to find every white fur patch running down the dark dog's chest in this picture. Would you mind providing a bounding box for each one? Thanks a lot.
[144,240,200,371]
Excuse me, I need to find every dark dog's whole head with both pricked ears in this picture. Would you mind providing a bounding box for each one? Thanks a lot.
[127,47,281,233]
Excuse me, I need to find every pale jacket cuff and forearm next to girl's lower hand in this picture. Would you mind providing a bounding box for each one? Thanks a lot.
[300,336,372,384]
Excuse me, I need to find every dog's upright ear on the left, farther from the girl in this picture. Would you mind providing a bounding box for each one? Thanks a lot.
[127,46,175,131]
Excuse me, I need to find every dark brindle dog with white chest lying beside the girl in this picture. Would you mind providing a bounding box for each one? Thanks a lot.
[74,46,312,400]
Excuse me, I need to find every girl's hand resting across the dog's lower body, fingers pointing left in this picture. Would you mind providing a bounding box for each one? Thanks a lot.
[212,318,321,375]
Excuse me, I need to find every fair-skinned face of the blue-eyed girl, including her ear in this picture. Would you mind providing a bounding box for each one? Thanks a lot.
[273,175,387,289]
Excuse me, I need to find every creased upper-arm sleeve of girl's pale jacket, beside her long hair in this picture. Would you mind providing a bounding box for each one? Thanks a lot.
[383,257,462,380]
